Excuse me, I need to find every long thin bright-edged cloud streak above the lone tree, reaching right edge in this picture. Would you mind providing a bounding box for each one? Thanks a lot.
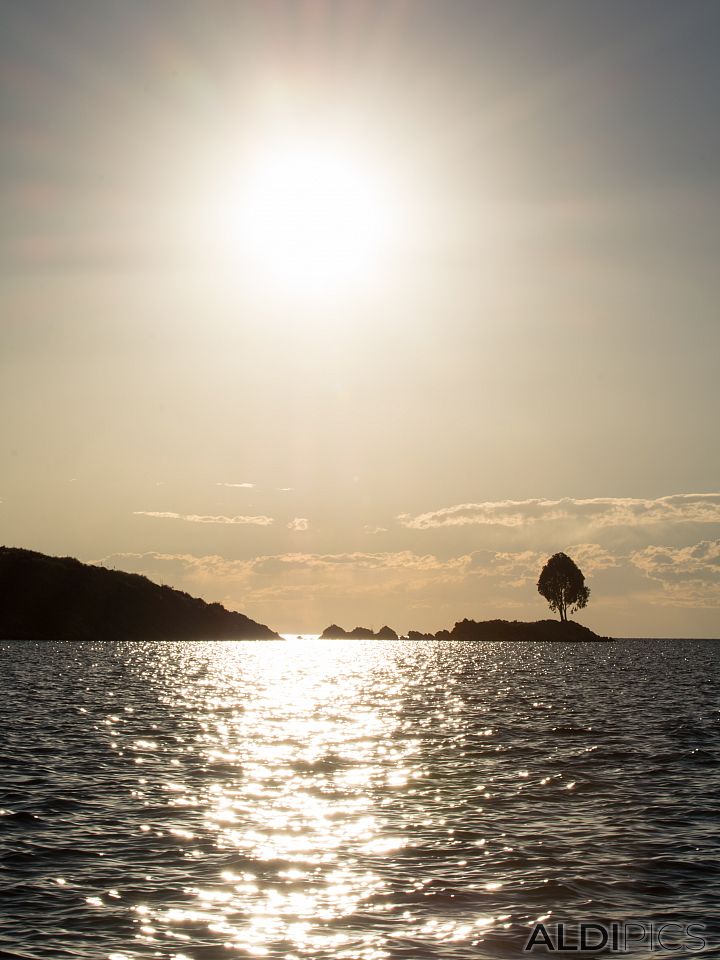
[397,493,720,530]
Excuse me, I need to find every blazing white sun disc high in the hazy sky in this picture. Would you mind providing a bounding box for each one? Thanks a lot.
[232,137,397,296]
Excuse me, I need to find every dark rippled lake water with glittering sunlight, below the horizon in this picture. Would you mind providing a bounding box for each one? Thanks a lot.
[0,641,720,960]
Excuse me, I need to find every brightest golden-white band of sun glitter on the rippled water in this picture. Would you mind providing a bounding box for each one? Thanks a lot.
[132,641,434,960]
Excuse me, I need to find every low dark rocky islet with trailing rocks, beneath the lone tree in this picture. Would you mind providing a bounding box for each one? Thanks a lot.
[320,620,611,642]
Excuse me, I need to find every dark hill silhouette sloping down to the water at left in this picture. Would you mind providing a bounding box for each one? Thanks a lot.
[0,547,277,640]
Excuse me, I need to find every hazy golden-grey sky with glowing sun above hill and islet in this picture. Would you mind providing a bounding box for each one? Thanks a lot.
[0,0,720,637]
